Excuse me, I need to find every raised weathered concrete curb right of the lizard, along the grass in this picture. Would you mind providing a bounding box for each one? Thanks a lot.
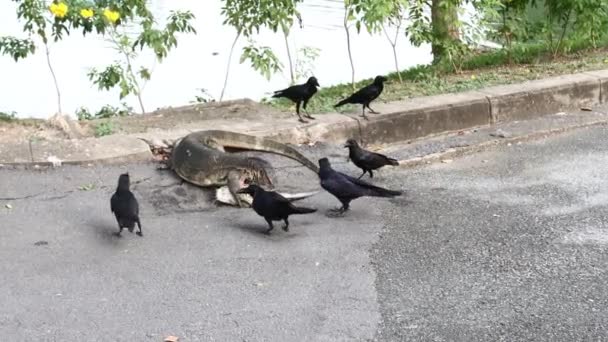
[268,70,608,144]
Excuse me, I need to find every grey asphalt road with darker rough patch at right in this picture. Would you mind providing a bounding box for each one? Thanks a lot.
[0,128,608,341]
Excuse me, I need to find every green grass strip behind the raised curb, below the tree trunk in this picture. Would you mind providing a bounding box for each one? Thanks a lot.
[262,40,608,114]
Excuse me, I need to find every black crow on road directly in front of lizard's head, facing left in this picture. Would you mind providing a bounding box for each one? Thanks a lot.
[237,184,317,234]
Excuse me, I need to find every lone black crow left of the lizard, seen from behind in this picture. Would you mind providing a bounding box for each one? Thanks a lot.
[110,173,143,236]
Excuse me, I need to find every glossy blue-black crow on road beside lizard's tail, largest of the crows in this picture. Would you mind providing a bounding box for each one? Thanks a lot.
[319,158,402,214]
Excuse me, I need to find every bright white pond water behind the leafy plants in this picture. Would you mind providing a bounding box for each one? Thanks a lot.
[0,0,442,118]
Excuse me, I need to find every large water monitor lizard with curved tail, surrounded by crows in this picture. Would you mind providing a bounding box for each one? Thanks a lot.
[170,130,319,207]
